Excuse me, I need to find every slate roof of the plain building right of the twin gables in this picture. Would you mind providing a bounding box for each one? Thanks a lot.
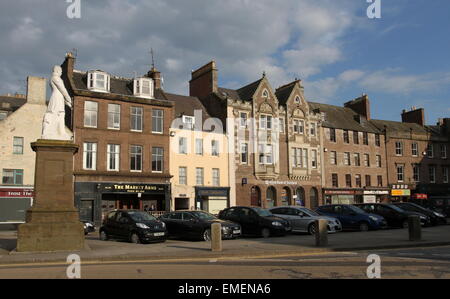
[308,102,381,133]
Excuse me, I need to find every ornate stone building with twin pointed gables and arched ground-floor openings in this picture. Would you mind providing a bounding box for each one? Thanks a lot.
[190,61,322,208]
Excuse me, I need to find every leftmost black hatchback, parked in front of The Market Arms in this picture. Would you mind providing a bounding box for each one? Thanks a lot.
[99,210,167,243]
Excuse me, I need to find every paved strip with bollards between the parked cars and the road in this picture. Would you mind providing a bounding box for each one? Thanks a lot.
[0,225,450,267]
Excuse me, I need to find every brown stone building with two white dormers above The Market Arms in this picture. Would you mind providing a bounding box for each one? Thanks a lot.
[62,53,174,223]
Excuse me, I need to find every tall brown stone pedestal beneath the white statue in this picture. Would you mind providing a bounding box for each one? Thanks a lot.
[17,139,84,252]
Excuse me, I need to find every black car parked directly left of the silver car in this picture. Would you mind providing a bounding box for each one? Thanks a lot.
[219,207,291,238]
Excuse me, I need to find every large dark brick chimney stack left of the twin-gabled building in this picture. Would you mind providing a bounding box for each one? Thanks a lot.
[189,61,218,99]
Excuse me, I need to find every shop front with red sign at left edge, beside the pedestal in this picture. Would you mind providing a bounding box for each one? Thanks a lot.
[0,187,34,224]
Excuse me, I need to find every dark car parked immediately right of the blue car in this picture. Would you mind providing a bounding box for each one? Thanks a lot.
[355,203,430,228]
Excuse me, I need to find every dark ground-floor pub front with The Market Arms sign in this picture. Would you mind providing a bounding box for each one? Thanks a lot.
[75,182,170,223]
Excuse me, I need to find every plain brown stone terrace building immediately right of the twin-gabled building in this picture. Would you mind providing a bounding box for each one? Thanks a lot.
[310,96,389,204]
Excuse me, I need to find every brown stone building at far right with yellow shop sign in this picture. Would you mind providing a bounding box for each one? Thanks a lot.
[372,107,450,201]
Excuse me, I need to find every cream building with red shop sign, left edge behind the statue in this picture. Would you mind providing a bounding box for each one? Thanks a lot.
[0,77,47,222]
